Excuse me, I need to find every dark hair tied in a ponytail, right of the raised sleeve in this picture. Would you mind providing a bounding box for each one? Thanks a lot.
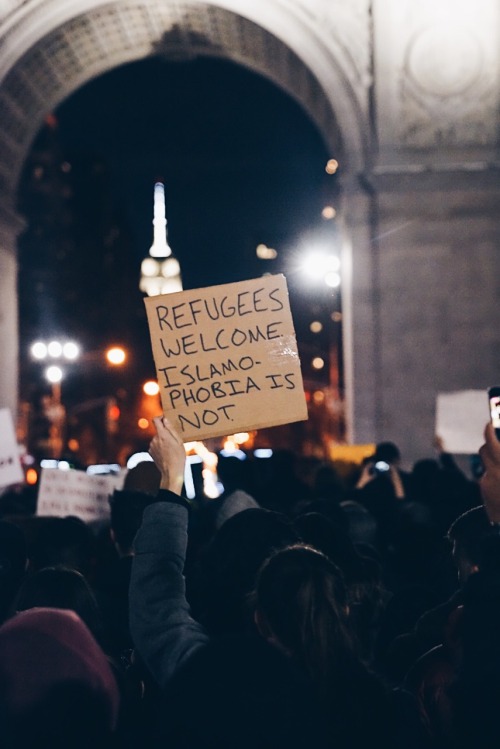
[256,544,352,695]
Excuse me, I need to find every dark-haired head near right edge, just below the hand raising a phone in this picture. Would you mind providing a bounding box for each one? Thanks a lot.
[447,505,491,585]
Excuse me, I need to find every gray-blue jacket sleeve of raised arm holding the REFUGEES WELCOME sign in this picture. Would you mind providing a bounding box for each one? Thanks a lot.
[130,501,209,687]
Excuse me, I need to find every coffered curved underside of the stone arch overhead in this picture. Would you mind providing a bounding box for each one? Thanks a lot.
[0,0,341,205]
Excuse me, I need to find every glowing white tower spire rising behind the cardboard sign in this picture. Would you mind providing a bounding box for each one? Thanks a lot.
[139,182,182,296]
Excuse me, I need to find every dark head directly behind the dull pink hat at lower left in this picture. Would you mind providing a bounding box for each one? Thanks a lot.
[14,567,101,637]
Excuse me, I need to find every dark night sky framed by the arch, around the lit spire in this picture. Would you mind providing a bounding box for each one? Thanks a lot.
[57,54,331,288]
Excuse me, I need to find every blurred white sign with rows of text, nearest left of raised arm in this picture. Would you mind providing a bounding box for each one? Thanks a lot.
[36,468,125,523]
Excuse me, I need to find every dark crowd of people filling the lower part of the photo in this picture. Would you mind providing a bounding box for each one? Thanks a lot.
[0,417,500,749]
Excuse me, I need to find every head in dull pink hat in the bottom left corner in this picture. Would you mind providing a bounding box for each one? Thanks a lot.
[0,608,120,749]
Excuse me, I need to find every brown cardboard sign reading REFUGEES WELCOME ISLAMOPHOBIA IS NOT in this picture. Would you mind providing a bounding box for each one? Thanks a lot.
[144,275,307,442]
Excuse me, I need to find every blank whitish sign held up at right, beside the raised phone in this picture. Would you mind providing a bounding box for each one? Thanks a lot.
[436,390,490,455]
